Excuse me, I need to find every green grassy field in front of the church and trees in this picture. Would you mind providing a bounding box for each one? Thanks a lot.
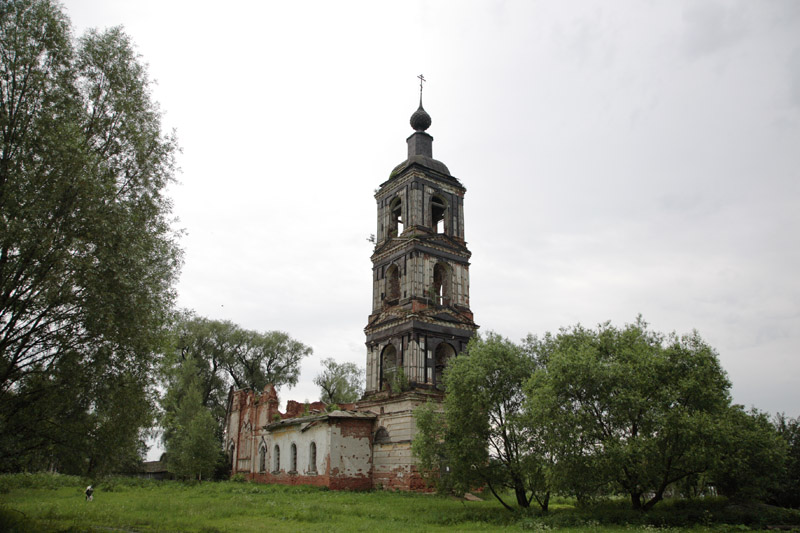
[0,474,800,533]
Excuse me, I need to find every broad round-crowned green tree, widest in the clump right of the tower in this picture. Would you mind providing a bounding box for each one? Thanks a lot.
[526,317,730,510]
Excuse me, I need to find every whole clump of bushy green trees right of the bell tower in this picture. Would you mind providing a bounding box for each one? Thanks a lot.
[412,317,800,511]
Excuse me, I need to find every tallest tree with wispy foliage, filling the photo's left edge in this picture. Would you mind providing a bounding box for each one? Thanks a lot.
[0,0,180,470]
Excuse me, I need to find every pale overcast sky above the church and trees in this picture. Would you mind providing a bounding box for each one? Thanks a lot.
[64,0,800,456]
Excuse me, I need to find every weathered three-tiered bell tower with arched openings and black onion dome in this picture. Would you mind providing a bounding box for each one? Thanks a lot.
[364,89,478,394]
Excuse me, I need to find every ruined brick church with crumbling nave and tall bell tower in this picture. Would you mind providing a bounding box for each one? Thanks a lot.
[224,92,478,490]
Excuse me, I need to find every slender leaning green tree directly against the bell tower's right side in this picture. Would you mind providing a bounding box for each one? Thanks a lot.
[415,333,550,510]
